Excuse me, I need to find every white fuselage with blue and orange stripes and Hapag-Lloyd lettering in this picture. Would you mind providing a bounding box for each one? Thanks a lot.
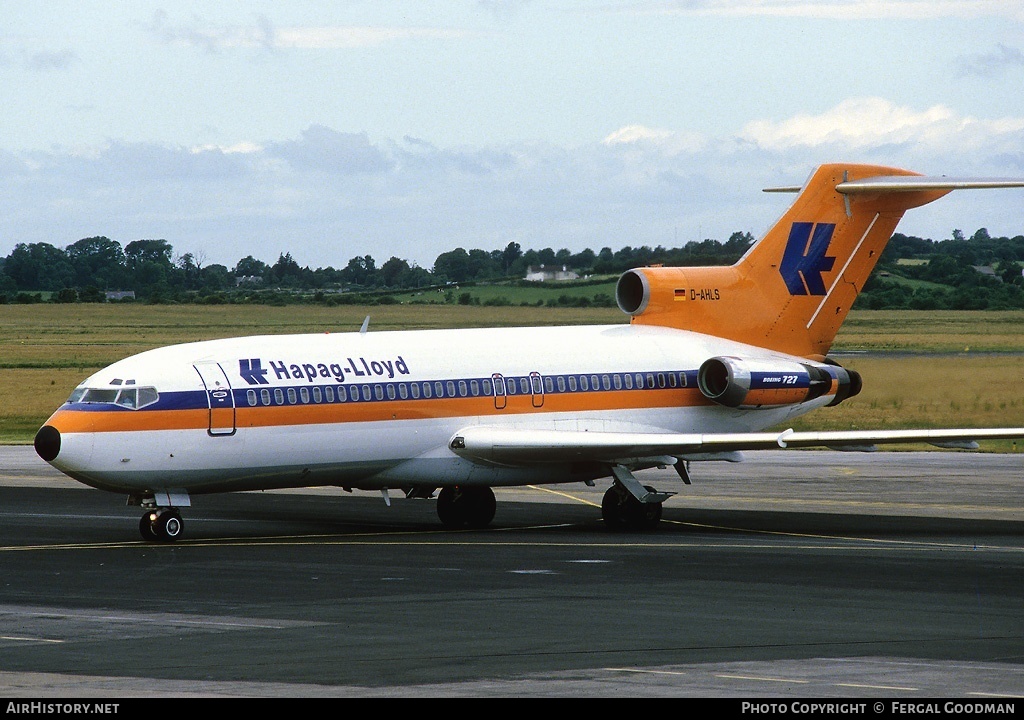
[39,325,829,493]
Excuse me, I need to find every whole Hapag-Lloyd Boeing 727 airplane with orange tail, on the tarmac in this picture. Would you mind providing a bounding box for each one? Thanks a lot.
[34,163,1024,542]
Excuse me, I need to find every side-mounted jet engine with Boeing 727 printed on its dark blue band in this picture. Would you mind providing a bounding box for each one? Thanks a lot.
[697,356,861,408]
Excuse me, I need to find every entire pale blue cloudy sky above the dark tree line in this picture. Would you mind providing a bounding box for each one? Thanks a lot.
[0,0,1024,268]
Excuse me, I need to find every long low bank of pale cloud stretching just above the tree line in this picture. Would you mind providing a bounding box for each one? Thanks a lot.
[0,104,1024,267]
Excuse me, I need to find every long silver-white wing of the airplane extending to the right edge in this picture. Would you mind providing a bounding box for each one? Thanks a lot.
[449,426,1024,465]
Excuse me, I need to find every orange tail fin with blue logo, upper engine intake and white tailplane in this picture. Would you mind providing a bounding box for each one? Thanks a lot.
[615,164,1024,359]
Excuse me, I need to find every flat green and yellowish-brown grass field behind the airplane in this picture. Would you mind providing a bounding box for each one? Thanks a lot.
[0,304,1024,450]
